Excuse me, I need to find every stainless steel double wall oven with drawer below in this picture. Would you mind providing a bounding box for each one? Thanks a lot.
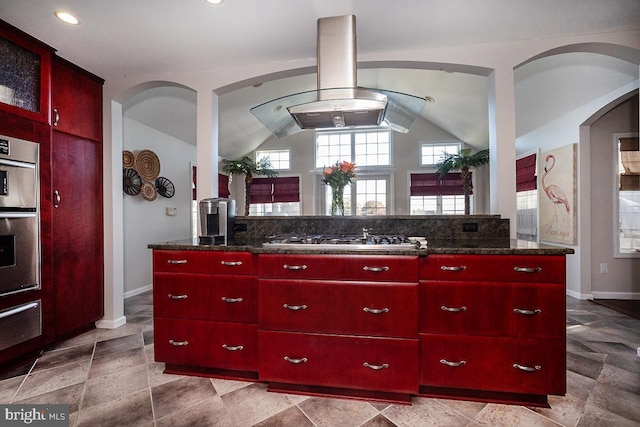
[0,136,42,350]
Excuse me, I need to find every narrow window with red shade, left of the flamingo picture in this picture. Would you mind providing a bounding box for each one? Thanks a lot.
[516,153,538,241]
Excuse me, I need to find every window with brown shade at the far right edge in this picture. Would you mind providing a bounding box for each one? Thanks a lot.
[614,135,640,257]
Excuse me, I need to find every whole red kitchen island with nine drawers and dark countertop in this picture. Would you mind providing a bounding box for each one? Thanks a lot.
[149,239,573,406]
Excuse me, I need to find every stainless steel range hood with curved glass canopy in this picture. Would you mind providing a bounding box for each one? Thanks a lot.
[251,15,426,138]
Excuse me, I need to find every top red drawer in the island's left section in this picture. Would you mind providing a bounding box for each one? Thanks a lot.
[153,250,256,275]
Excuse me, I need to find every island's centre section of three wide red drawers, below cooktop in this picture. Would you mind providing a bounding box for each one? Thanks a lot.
[258,254,418,393]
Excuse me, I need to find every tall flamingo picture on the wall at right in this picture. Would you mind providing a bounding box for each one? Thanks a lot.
[540,145,576,244]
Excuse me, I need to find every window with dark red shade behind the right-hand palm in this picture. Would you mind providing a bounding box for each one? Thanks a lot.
[409,172,473,215]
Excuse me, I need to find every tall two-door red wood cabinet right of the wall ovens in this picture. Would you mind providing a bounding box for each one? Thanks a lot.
[49,57,104,337]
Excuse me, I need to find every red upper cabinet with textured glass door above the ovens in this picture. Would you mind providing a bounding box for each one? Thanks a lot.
[0,20,55,123]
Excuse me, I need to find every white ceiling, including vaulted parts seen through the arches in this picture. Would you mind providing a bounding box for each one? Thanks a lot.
[0,0,640,158]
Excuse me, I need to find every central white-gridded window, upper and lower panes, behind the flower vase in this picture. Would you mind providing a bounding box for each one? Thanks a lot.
[316,129,392,215]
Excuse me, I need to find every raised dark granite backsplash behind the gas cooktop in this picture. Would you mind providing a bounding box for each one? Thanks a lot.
[233,215,509,244]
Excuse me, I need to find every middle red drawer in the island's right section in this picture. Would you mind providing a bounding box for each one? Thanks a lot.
[420,281,566,338]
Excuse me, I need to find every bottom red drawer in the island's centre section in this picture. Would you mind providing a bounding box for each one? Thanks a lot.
[258,330,418,393]
